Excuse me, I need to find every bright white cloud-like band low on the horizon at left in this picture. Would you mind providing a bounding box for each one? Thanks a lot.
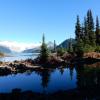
[0,41,41,52]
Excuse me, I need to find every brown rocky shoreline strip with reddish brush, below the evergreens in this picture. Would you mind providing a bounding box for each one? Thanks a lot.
[0,53,100,75]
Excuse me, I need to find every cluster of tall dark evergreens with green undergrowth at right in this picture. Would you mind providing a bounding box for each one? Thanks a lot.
[74,10,100,54]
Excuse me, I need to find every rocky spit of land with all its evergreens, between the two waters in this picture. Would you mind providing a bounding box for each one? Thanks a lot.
[0,10,100,73]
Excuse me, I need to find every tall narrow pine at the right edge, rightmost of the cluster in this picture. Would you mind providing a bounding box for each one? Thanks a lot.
[95,16,100,46]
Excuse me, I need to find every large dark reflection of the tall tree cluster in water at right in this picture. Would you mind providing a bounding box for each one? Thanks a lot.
[76,63,100,88]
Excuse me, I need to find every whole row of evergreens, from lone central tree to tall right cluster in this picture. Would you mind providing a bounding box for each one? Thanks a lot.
[39,10,100,63]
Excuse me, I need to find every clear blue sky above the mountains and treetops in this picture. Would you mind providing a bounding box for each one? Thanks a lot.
[0,0,100,43]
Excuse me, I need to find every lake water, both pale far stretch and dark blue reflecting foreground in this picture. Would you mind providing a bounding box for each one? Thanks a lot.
[0,54,100,100]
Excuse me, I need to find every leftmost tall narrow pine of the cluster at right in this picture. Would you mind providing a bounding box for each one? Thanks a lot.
[75,16,81,41]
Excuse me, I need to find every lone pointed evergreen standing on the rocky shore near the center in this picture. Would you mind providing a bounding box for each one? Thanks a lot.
[40,34,49,63]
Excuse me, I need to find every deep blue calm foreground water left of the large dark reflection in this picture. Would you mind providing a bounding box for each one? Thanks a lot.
[0,68,77,93]
